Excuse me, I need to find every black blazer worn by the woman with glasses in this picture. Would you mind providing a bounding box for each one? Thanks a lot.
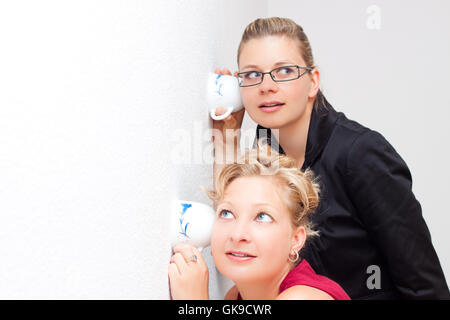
[255,98,450,299]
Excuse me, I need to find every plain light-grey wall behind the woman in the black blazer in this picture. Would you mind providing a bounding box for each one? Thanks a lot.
[268,0,450,283]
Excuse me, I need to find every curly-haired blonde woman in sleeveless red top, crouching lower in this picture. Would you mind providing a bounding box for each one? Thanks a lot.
[169,147,349,300]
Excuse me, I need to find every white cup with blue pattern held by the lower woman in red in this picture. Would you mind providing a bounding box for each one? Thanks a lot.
[170,200,215,250]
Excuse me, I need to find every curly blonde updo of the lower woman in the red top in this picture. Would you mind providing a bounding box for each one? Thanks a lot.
[204,140,319,237]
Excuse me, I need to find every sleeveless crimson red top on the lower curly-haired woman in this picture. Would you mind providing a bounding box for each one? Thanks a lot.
[237,259,350,300]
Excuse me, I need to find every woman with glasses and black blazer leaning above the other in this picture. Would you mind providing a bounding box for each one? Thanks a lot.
[213,18,450,299]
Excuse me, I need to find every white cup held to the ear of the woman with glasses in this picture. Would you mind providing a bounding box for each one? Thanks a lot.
[206,72,244,120]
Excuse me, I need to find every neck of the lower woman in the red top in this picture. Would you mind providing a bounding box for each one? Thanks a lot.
[235,264,292,300]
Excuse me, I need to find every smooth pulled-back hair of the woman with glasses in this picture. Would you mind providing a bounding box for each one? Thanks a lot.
[237,17,324,108]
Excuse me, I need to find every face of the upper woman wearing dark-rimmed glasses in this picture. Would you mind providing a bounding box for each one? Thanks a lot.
[239,36,320,129]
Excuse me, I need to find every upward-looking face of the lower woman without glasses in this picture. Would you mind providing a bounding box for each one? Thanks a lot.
[211,176,305,282]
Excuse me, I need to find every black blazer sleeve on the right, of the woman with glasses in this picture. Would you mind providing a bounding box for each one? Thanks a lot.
[346,131,450,299]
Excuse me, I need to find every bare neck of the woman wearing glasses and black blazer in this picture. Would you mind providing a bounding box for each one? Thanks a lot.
[272,100,314,168]
